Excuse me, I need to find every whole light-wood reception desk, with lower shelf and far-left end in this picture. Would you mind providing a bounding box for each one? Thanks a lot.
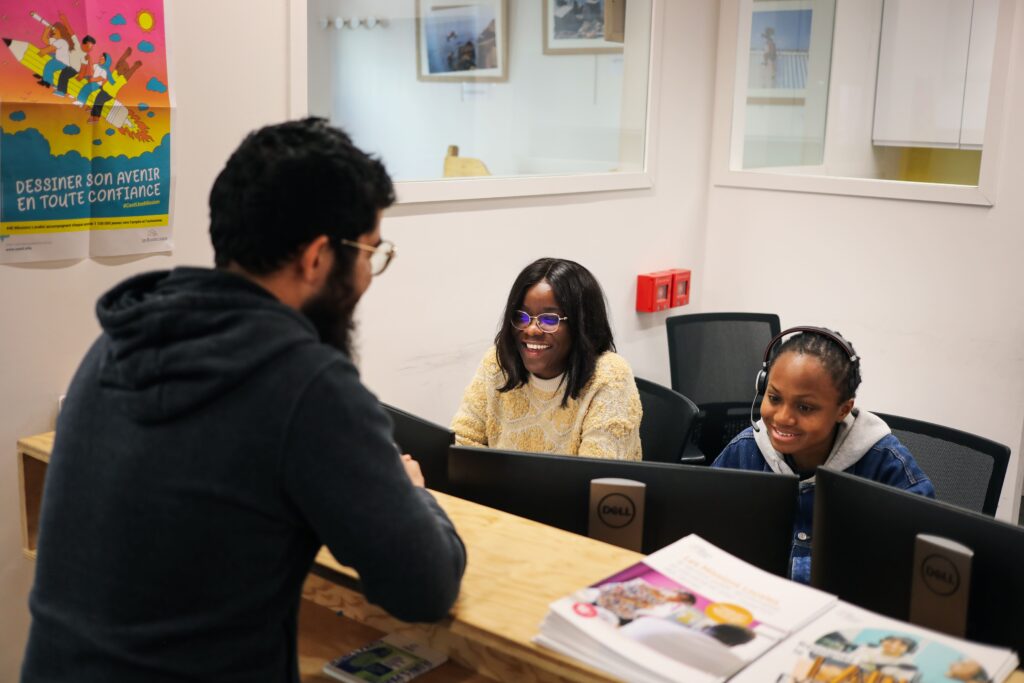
[17,432,1024,683]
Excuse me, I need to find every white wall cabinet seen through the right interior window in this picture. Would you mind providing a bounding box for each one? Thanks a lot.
[872,0,998,150]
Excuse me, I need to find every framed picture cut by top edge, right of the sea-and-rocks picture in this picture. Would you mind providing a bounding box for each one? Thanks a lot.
[543,0,623,54]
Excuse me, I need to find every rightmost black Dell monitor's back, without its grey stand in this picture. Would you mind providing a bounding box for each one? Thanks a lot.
[811,468,1024,652]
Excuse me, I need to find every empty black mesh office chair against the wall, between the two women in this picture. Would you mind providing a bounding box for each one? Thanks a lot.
[665,313,781,461]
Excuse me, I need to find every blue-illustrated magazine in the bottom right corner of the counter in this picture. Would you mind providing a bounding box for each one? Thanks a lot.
[735,602,1017,683]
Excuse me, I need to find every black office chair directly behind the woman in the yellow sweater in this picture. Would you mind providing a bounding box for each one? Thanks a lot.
[636,377,707,465]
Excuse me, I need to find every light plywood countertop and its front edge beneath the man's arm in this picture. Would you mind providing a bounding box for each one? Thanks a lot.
[303,493,643,682]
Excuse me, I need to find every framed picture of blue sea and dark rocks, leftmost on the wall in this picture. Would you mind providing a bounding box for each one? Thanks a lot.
[416,0,509,82]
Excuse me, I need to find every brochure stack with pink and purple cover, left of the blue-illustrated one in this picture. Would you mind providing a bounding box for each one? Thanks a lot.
[536,536,837,683]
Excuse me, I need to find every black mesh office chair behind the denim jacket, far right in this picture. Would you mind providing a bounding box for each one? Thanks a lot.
[876,413,1010,516]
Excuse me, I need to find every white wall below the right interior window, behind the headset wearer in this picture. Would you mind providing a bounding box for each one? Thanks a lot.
[701,2,1024,518]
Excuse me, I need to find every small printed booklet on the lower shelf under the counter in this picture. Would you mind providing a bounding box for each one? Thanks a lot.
[324,633,447,683]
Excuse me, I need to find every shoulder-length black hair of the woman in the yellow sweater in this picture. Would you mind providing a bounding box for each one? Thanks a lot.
[495,258,615,407]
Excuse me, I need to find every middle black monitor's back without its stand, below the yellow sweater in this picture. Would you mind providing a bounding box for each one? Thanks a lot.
[449,446,798,575]
